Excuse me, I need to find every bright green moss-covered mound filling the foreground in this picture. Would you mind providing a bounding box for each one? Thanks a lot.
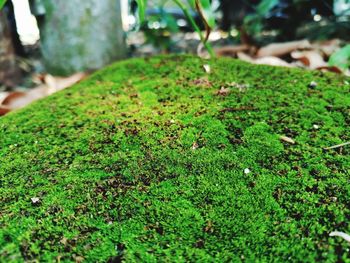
[0,56,350,262]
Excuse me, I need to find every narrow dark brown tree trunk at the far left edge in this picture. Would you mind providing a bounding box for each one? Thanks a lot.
[0,10,20,87]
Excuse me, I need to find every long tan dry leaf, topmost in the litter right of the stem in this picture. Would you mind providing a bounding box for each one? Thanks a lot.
[257,40,311,58]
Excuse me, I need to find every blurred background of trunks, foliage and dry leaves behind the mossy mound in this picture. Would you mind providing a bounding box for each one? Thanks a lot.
[0,0,350,115]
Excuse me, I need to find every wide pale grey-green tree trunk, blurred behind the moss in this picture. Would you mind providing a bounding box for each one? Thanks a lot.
[37,0,126,75]
